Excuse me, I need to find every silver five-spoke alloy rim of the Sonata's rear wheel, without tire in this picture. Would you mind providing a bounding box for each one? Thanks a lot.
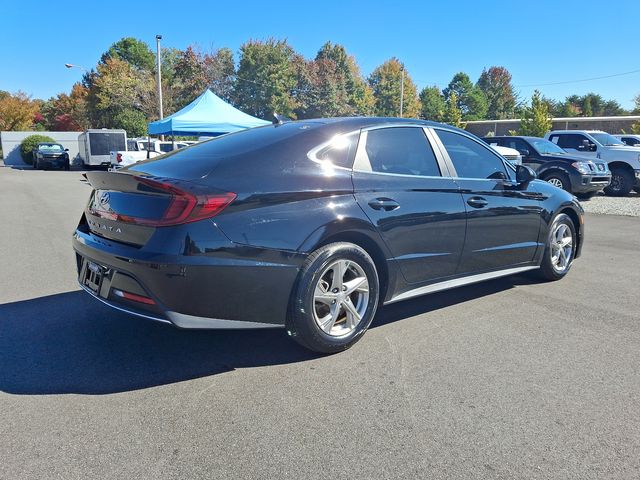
[313,259,369,337]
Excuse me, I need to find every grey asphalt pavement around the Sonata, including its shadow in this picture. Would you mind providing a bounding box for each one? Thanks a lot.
[0,167,640,479]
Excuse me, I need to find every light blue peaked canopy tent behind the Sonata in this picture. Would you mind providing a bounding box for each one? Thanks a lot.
[149,89,271,137]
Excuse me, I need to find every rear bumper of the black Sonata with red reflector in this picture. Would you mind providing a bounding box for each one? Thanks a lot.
[73,222,304,329]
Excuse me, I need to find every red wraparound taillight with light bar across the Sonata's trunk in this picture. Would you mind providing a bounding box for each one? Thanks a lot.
[89,177,237,227]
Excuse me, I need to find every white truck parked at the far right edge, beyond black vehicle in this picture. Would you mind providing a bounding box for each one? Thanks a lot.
[544,130,640,197]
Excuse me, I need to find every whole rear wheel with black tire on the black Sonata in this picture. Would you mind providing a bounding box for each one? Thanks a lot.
[286,242,380,353]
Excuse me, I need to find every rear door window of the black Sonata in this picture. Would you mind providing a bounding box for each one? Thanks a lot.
[365,127,440,177]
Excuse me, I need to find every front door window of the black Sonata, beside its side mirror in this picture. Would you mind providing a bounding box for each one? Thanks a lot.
[435,130,509,179]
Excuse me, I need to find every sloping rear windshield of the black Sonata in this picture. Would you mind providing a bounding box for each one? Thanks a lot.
[128,122,321,180]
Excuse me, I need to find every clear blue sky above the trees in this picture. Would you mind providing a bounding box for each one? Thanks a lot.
[0,0,640,108]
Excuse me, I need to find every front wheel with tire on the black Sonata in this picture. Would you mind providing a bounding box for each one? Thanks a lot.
[539,213,577,281]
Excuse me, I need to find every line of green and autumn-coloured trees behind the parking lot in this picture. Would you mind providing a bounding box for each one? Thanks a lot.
[0,37,640,136]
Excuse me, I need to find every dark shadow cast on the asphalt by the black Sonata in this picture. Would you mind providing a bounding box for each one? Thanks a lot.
[0,277,536,395]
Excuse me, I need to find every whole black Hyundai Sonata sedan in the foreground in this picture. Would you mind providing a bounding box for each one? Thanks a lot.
[73,118,583,353]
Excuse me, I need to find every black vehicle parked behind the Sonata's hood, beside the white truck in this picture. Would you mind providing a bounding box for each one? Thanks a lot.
[483,136,611,200]
